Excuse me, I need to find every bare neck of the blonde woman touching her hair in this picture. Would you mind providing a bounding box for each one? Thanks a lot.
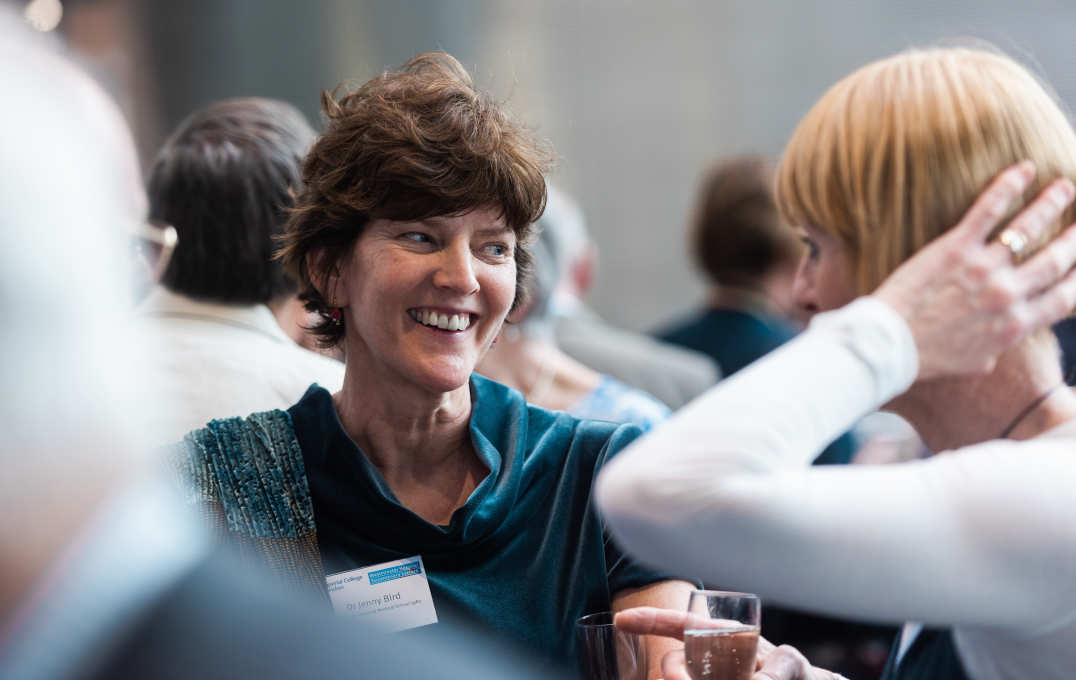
[887,339,1076,451]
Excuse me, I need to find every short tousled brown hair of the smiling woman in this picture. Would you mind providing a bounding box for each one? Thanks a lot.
[279,53,551,345]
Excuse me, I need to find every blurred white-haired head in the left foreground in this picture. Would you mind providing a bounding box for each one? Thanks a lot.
[0,8,145,618]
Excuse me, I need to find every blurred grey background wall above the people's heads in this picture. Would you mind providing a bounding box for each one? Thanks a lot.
[138,0,1076,328]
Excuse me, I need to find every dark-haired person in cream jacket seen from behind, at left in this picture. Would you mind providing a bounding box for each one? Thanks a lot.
[138,97,343,443]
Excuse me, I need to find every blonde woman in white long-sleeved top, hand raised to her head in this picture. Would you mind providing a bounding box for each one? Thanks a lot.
[597,48,1076,680]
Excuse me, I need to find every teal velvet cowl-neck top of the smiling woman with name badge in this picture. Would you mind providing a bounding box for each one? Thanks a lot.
[288,376,675,663]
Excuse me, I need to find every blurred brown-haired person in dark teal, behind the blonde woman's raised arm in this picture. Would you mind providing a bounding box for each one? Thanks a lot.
[655,155,895,677]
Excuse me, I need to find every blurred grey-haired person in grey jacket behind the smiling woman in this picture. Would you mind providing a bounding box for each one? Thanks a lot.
[542,187,721,410]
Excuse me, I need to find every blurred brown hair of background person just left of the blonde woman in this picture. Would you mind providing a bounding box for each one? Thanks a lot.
[690,156,801,288]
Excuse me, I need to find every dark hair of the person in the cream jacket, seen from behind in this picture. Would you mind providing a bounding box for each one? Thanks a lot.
[147,97,314,304]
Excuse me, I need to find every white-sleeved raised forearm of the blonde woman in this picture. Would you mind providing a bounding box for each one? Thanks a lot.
[597,298,916,535]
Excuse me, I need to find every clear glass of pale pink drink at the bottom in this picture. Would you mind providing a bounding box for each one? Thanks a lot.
[683,591,762,680]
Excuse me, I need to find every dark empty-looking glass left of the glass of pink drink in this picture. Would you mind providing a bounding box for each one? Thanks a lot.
[576,611,647,680]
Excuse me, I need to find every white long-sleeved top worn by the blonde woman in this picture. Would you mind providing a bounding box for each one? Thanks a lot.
[596,298,1076,680]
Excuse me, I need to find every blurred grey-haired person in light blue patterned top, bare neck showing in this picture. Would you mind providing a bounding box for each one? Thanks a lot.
[478,186,669,430]
